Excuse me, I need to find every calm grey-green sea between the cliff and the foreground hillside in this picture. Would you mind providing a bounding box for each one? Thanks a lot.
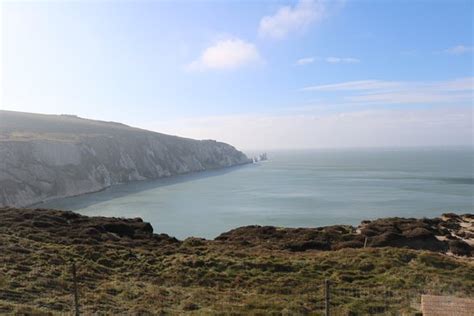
[41,149,474,238]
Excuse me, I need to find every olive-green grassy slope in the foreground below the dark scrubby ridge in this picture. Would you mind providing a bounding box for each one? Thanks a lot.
[0,209,474,314]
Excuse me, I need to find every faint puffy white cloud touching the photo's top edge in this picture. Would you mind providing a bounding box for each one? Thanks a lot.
[259,0,325,39]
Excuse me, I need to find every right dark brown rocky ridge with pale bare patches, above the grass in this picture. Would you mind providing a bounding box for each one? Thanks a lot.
[216,214,474,257]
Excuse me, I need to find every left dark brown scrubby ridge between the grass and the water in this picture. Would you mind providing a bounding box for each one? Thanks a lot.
[0,208,179,249]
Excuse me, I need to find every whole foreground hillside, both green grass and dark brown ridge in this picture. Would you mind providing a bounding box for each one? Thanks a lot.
[0,208,474,315]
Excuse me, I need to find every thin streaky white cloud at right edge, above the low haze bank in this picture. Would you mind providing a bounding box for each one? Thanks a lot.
[302,77,474,105]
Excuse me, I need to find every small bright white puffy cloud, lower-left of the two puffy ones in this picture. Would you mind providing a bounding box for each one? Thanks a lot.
[186,39,262,71]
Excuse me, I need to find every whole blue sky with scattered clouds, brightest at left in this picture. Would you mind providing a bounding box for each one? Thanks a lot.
[0,0,474,150]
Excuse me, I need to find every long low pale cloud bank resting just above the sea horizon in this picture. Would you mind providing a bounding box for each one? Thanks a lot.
[146,107,472,150]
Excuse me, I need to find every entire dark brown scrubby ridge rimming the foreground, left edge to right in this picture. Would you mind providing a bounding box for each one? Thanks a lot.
[0,207,474,257]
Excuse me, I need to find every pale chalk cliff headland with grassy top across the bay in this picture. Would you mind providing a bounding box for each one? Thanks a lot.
[0,111,249,206]
